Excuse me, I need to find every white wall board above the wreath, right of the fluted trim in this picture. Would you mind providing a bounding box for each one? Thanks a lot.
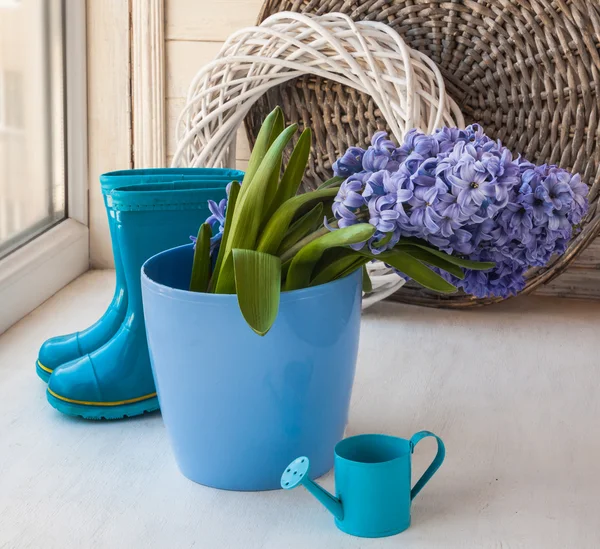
[166,0,262,42]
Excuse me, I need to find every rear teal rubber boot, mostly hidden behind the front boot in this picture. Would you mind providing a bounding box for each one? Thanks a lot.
[36,168,239,382]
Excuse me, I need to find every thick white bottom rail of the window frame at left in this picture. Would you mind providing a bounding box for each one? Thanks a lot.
[0,219,89,334]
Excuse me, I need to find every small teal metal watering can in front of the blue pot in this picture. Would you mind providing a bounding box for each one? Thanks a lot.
[281,431,446,538]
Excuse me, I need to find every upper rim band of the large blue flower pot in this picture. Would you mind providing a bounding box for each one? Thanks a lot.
[142,244,362,306]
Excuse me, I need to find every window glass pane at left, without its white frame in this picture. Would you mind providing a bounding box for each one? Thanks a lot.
[0,0,65,257]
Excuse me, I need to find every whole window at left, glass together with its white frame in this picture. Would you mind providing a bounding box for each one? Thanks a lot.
[0,0,88,333]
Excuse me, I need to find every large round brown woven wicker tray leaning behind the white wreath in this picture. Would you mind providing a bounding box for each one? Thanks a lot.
[246,0,600,307]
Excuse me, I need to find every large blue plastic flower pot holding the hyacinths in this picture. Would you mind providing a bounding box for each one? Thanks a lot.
[142,245,361,490]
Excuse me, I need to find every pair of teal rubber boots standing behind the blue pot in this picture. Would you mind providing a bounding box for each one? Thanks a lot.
[36,168,243,419]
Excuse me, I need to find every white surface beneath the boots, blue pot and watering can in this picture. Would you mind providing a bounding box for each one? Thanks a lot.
[0,271,600,549]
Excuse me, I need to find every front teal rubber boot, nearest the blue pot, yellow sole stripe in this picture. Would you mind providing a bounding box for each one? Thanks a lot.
[47,182,226,419]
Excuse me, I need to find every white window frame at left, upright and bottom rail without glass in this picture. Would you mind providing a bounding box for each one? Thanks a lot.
[0,0,89,334]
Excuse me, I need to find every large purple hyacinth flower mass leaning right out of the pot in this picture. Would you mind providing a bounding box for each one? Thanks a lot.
[334,124,588,297]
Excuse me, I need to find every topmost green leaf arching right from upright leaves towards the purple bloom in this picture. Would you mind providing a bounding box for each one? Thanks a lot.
[256,189,337,254]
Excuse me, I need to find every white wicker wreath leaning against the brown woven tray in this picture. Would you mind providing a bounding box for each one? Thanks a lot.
[172,12,464,308]
